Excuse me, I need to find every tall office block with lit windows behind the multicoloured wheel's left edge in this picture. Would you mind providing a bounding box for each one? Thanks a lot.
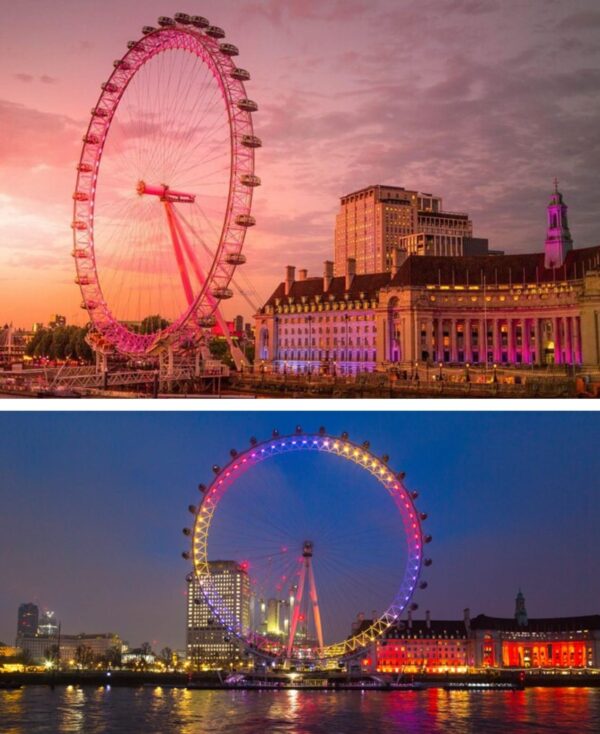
[186,561,252,669]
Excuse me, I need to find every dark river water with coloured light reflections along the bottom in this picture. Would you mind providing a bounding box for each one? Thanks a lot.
[0,686,600,734]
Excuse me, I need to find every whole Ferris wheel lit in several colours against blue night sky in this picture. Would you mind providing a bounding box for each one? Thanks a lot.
[183,426,431,664]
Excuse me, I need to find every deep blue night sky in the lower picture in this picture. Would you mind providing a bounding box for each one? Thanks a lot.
[0,411,600,648]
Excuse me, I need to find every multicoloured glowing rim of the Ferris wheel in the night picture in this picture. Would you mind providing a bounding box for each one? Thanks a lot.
[184,431,431,660]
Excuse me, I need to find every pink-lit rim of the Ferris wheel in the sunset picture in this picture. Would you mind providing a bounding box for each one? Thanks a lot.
[72,25,258,355]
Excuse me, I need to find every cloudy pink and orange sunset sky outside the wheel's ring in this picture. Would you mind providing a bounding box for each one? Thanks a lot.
[0,0,600,326]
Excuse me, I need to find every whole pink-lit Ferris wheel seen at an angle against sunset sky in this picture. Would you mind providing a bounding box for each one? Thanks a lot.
[72,13,262,356]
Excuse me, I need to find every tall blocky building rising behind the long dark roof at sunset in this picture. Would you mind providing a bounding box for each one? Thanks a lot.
[334,186,488,275]
